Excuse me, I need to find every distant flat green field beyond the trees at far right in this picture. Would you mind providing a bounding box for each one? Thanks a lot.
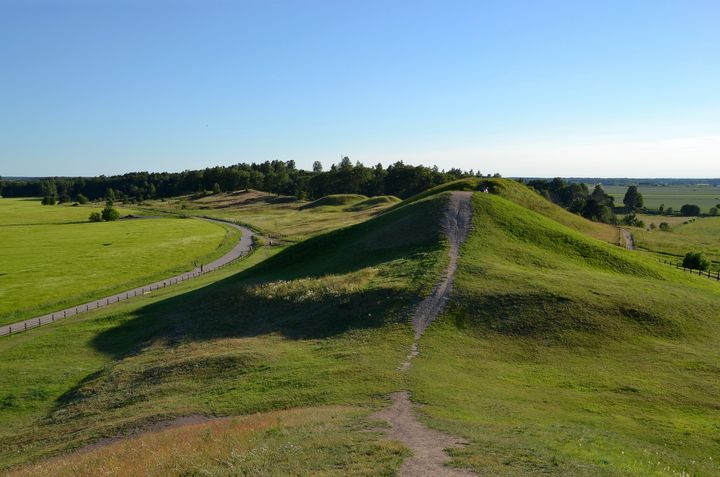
[600,184,720,213]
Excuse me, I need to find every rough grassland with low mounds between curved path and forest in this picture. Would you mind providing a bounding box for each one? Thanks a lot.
[142,190,399,242]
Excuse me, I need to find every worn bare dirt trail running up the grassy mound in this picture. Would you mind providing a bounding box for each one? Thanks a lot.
[372,192,475,477]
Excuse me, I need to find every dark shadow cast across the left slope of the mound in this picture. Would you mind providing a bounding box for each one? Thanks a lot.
[87,195,444,358]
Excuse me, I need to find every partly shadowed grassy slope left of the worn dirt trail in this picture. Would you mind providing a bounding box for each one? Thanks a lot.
[0,192,447,468]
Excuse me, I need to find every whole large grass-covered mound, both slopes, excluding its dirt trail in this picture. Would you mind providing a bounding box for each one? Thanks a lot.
[0,179,720,476]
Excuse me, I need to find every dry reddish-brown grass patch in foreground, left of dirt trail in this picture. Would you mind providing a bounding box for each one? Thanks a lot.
[9,406,404,477]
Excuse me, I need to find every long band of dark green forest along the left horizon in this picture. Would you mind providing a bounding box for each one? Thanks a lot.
[0,157,480,203]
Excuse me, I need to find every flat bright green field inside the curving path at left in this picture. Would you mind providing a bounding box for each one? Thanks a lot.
[0,199,238,324]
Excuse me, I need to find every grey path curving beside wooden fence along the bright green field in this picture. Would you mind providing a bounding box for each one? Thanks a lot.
[0,217,254,336]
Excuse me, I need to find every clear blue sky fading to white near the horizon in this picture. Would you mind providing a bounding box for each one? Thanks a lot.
[0,0,720,177]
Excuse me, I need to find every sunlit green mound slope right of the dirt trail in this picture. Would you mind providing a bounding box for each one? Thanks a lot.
[410,193,720,476]
